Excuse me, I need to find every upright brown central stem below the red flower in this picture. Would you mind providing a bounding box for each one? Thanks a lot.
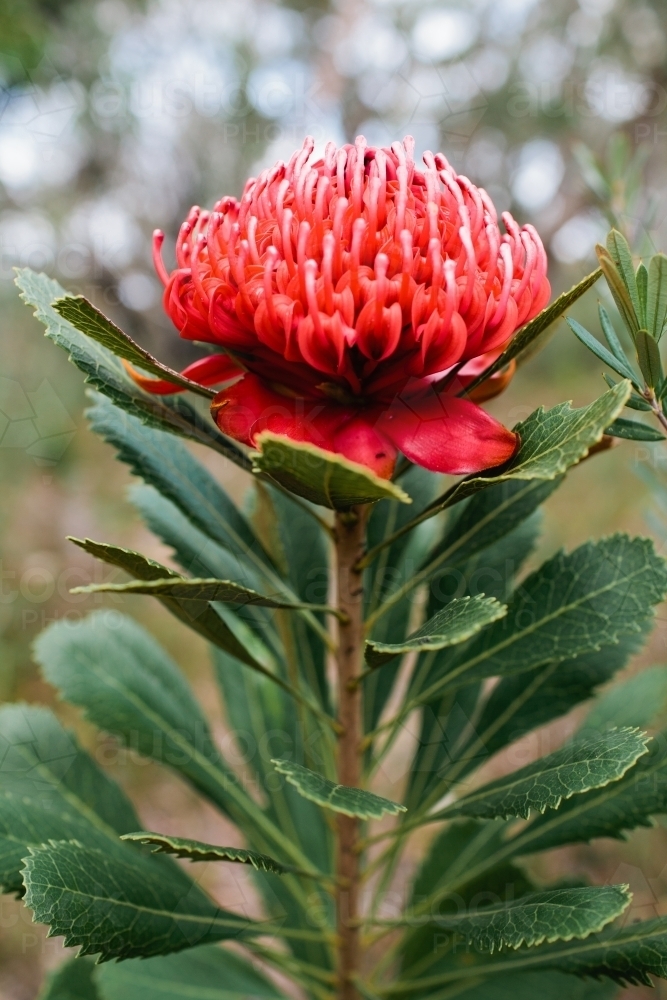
[335,507,368,1000]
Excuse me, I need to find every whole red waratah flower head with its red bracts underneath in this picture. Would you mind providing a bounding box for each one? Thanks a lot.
[142,136,550,477]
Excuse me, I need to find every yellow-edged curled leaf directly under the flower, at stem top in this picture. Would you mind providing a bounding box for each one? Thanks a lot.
[251,431,411,510]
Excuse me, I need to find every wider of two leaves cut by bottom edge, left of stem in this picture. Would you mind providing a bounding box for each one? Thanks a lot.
[97,945,282,1000]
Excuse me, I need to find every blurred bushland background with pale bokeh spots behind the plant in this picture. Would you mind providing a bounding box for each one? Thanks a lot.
[0,0,667,1000]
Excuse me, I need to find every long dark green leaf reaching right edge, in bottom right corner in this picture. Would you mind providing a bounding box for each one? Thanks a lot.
[385,917,667,997]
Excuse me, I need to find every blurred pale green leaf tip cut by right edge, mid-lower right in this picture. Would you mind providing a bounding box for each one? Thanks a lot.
[582,667,667,732]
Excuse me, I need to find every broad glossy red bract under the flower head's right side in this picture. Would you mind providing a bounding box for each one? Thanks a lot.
[378,389,518,475]
